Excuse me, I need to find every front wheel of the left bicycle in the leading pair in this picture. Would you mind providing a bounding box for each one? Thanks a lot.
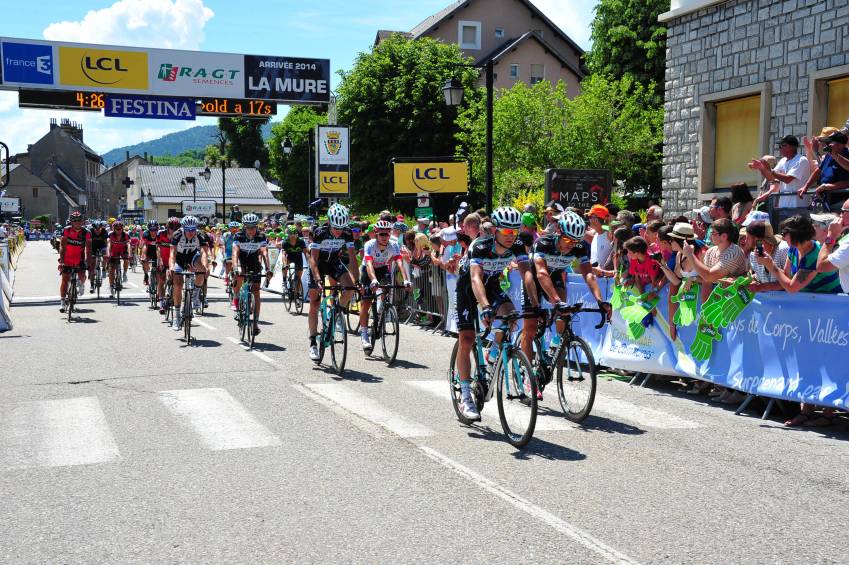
[496,348,537,447]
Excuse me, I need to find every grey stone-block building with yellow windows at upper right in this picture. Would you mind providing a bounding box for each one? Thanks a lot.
[659,0,849,212]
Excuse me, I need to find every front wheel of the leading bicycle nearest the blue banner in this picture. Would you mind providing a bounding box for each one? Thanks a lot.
[554,337,596,423]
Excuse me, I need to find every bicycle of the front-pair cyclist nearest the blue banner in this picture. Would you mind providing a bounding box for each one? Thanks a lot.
[531,302,607,424]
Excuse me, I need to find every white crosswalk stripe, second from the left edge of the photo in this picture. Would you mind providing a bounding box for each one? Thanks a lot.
[159,388,281,451]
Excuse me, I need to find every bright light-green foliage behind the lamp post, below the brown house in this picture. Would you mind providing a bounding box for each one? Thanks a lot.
[457,76,663,205]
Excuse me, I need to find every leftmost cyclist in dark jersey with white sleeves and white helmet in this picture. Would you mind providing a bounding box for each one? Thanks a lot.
[168,216,209,331]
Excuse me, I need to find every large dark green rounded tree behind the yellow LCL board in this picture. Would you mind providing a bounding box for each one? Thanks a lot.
[338,35,480,211]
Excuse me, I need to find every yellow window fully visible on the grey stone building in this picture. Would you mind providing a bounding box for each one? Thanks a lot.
[713,96,761,188]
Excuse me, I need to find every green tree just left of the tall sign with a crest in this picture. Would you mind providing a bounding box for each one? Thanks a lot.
[268,106,327,213]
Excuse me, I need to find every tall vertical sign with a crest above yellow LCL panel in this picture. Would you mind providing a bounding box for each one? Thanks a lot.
[315,126,351,197]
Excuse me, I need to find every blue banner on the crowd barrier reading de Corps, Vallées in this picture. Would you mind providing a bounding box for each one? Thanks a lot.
[568,275,849,409]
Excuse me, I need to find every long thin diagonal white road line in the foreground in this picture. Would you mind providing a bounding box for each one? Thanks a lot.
[417,445,637,564]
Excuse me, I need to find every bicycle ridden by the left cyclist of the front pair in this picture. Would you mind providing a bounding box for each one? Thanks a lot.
[448,312,539,448]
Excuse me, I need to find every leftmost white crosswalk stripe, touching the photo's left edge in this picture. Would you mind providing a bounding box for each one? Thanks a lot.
[0,396,121,468]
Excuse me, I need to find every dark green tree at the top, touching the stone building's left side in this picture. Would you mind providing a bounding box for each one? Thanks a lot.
[586,0,670,100]
